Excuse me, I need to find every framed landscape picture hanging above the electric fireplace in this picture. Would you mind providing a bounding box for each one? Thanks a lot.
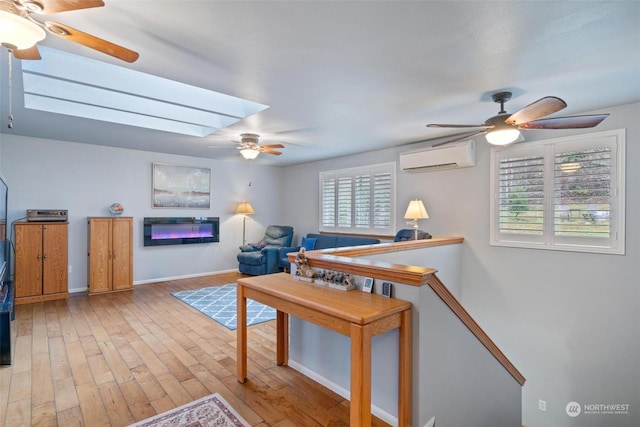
[151,163,211,209]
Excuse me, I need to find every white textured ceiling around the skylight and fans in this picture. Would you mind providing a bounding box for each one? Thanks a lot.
[0,0,640,165]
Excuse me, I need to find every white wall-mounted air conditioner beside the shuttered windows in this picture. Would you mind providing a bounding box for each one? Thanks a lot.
[400,140,476,172]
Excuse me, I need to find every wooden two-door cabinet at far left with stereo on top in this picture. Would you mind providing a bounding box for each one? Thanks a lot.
[15,222,69,304]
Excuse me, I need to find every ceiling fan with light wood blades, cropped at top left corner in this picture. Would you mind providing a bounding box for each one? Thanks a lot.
[0,0,139,62]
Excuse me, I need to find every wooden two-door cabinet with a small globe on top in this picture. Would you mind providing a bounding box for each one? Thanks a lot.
[89,217,133,294]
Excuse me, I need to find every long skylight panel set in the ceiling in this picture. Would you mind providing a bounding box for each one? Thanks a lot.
[22,46,269,137]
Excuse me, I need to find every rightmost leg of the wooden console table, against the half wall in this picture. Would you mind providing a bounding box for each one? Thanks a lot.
[398,310,413,427]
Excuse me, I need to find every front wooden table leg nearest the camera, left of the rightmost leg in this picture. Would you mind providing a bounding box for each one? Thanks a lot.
[349,324,373,427]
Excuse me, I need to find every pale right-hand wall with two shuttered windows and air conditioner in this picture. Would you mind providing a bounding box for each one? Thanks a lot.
[283,104,640,427]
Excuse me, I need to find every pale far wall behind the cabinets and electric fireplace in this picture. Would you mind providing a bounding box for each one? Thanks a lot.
[0,134,281,291]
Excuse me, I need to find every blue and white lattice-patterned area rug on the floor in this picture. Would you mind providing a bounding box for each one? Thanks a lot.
[171,283,276,331]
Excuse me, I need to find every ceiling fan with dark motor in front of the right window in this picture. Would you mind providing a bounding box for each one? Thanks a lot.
[427,92,609,147]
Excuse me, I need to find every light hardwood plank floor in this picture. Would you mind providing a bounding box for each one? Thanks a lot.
[0,273,388,427]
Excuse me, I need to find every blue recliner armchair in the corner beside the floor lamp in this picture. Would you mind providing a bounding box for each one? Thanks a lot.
[237,225,293,276]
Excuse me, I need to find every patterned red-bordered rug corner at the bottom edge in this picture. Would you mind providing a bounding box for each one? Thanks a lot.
[129,393,251,427]
